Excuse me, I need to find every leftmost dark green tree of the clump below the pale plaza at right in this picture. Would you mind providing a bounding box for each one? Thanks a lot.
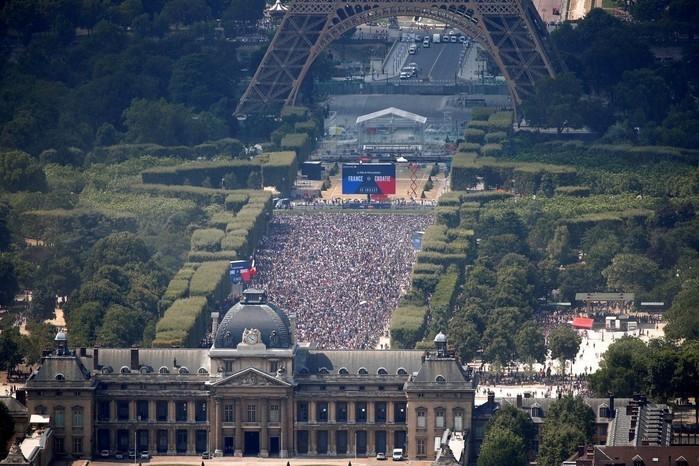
[590,337,649,397]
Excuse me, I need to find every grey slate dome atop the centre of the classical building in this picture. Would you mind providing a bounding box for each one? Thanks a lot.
[214,289,292,348]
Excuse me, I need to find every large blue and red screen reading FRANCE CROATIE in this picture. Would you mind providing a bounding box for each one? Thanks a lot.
[342,163,396,194]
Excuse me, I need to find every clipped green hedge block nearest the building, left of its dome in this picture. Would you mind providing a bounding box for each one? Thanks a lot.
[153,297,209,348]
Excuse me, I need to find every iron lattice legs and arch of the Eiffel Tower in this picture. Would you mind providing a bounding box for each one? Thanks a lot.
[236,0,558,115]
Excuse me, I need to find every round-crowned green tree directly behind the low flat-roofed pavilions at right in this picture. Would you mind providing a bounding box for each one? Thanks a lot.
[602,254,660,294]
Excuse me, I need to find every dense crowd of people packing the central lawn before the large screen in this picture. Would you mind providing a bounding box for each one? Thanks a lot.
[255,213,432,349]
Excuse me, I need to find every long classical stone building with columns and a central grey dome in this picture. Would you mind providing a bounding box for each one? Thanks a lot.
[26,290,475,459]
